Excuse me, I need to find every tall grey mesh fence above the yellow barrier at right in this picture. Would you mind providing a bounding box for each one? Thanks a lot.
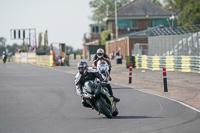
[148,32,200,56]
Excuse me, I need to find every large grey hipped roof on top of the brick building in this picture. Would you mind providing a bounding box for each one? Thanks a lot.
[108,0,174,17]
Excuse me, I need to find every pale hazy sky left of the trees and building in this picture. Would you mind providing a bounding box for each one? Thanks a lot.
[0,0,94,49]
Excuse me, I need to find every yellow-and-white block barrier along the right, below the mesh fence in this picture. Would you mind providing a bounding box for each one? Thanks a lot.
[135,56,200,73]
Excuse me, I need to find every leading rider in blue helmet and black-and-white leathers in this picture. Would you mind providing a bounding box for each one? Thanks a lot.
[75,61,120,107]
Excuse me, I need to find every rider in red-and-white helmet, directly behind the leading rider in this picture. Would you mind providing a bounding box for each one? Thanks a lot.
[92,48,111,80]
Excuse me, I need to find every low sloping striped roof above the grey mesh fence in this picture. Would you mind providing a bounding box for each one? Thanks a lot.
[119,25,200,38]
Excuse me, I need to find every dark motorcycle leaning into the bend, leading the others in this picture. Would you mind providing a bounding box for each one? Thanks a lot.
[82,80,119,118]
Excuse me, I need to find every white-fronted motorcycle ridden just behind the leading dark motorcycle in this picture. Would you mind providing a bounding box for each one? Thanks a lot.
[97,60,110,81]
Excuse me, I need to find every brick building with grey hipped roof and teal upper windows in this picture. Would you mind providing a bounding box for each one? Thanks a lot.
[104,0,179,57]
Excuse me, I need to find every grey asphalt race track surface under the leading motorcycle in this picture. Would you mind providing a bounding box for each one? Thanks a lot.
[0,63,200,133]
